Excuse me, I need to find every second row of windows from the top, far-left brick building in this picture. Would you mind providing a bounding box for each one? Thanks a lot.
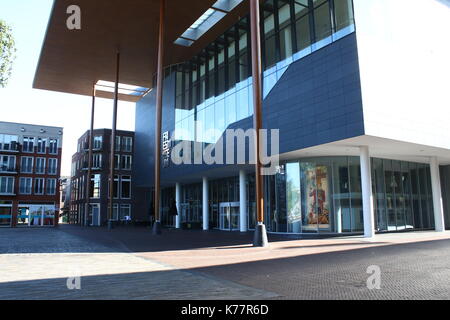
[0,155,58,175]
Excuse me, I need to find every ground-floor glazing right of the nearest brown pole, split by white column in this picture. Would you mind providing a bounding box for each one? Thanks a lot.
[266,157,434,234]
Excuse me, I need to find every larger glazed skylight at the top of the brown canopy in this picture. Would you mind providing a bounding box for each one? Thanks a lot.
[175,0,243,47]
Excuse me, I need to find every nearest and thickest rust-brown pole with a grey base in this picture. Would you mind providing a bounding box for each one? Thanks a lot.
[250,0,268,247]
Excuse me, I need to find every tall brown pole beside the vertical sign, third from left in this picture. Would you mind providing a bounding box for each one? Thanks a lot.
[153,0,166,235]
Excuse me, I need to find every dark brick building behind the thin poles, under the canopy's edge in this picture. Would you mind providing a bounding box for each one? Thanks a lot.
[69,129,136,226]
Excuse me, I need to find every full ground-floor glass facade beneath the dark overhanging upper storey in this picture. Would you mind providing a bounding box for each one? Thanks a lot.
[162,157,434,234]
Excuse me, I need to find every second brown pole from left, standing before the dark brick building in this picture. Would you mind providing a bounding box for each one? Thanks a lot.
[108,50,120,229]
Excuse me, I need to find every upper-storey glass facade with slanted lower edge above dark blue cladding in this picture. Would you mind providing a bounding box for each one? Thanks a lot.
[166,0,354,150]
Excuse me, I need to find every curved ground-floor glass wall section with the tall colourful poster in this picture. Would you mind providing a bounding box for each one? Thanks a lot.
[266,157,363,233]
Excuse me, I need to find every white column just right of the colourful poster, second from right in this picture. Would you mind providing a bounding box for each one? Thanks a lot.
[360,146,375,238]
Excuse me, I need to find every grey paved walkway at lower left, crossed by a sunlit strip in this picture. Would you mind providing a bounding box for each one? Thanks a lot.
[0,229,277,300]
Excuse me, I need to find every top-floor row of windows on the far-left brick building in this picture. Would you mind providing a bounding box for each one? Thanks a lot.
[0,134,58,154]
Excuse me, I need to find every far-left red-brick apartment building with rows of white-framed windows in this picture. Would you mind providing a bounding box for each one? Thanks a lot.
[0,122,63,227]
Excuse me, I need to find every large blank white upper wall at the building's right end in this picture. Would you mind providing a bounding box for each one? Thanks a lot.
[354,0,450,149]
